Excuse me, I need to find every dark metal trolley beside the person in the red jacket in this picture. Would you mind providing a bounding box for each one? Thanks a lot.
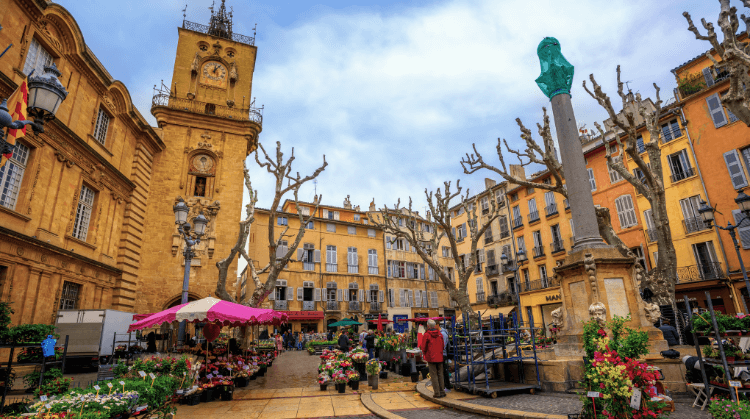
[443,313,541,398]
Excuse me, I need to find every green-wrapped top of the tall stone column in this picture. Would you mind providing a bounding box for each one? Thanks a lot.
[536,37,573,99]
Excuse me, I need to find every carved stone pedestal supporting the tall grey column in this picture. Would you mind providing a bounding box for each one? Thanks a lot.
[555,247,668,357]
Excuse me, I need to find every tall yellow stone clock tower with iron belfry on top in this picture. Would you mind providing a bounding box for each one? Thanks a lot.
[137,0,263,313]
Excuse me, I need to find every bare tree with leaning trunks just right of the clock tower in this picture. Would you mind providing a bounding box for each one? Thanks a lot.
[216,141,328,307]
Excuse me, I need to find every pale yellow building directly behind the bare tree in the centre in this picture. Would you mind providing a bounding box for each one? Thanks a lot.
[368,203,455,331]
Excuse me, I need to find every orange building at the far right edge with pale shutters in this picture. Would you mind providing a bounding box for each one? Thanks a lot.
[672,43,750,311]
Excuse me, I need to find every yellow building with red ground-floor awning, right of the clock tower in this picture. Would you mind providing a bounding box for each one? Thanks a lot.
[245,200,387,332]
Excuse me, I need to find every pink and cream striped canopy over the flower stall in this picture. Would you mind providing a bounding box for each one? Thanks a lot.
[128,297,288,332]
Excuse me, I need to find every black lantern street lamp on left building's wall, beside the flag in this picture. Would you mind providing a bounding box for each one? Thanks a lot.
[0,63,68,154]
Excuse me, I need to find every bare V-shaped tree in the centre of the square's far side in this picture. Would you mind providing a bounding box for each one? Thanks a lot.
[371,181,500,319]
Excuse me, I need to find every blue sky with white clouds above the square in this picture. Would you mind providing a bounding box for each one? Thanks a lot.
[60,0,742,217]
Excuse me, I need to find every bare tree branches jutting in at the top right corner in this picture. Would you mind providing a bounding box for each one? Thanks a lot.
[682,0,750,127]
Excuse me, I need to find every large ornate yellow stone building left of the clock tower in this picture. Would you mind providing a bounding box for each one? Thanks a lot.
[0,0,164,324]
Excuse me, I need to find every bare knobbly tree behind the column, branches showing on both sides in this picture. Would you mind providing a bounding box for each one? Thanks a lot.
[461,66,677,304]
